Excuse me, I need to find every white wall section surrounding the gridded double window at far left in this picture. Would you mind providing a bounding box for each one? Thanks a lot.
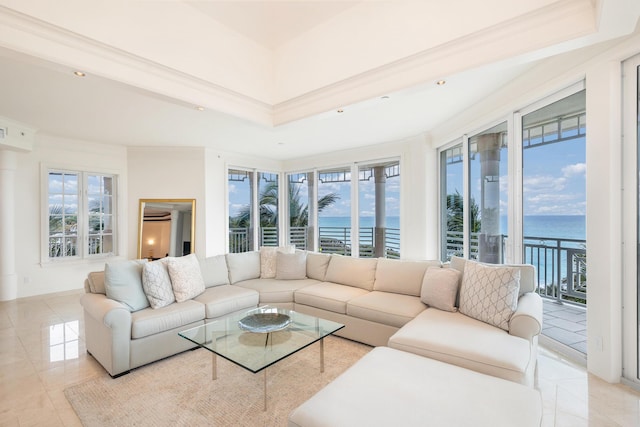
[13,134,127,298]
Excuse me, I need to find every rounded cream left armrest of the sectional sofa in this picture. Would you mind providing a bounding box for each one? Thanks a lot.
[80,294,131,376]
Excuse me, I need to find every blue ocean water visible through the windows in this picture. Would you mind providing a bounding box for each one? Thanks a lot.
[318,215,586,240]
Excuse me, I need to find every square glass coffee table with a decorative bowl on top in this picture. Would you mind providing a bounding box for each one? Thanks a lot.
[179,306,344,410]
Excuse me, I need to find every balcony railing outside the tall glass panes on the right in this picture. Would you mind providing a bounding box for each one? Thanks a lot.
[446,232,587,306]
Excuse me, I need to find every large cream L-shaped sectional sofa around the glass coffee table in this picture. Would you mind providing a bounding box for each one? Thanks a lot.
[81,250,542,385]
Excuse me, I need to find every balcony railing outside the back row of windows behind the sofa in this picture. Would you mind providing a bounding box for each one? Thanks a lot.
[229,227,400,259]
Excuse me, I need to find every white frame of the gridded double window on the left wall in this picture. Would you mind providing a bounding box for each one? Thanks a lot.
[40,163,119,265]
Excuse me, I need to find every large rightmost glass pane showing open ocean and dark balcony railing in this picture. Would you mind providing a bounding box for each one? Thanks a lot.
[522,90,586,304]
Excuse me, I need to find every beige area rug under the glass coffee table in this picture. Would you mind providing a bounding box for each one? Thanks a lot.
[64,336,371,427]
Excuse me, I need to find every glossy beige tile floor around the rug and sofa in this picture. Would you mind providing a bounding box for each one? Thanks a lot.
[0,291,640,427]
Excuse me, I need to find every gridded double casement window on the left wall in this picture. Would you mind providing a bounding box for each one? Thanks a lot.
[47,170,115,259]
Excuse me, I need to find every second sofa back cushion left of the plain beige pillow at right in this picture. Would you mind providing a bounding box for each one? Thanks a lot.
[325,254,378,291]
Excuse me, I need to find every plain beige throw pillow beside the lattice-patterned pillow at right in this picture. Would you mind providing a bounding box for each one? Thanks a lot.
[420,267,461,311]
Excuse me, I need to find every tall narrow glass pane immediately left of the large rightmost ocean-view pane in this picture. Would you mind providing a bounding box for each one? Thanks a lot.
[468,122,508,264]
